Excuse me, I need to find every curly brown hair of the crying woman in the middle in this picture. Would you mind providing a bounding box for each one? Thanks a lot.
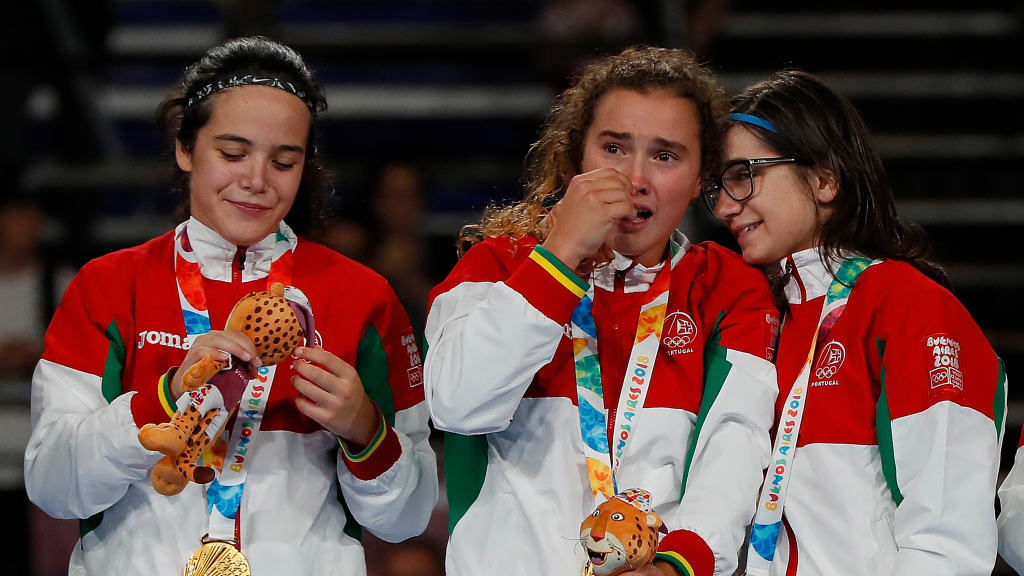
[458,46,728,252]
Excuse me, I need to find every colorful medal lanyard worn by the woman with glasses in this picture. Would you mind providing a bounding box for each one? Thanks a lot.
[746,258,878,576]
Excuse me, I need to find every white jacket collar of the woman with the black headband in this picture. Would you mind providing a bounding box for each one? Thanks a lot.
[184,217,298,282]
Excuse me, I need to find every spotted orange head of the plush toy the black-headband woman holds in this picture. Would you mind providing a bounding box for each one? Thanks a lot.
[225,283,306,366]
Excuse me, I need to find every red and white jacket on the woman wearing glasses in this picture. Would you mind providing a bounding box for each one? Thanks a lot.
[771,248,1007,576]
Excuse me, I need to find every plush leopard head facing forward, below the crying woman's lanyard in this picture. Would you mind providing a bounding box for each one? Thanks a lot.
[580,488,662,576]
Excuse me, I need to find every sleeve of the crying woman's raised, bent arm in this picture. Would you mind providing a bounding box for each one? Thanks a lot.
[424,241,586,435]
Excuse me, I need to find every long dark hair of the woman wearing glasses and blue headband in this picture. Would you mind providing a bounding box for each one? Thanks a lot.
[732,70,949,290]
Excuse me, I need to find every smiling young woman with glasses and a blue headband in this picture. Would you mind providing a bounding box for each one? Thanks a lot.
[702,72,1006,576]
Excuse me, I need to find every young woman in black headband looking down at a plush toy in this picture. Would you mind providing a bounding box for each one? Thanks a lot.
[25,38,437,575]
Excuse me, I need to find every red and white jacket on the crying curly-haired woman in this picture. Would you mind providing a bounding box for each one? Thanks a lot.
[424,235,778,576]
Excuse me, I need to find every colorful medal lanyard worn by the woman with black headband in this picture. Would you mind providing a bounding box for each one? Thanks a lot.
[174,222,297,548]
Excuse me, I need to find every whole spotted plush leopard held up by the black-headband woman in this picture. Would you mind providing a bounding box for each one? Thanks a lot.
[138,282,315,496]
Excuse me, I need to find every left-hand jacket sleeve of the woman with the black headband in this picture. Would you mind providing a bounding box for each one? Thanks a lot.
[25,261,162,519]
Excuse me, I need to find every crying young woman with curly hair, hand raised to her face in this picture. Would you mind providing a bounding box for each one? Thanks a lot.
[425,48,777,576]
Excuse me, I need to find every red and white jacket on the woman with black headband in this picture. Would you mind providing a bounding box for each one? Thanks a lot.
[25,219,437,576]
